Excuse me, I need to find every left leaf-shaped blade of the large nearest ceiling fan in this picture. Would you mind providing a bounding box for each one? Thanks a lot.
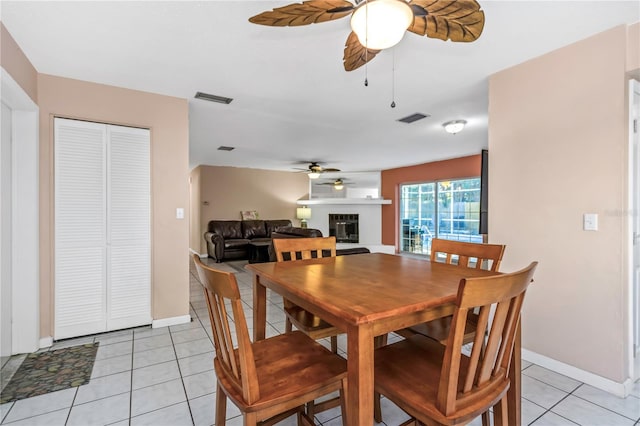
[249,0,354,27]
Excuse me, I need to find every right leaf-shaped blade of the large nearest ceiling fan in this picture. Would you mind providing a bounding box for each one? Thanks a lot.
[408,0,484,43]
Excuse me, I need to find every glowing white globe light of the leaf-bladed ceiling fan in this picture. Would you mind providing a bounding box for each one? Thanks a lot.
[351,0,414,50]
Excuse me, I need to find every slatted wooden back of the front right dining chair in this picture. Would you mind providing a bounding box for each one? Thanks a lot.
[437,262,538,416]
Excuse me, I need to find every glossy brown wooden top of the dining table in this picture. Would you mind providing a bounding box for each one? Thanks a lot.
[246,253,495,325]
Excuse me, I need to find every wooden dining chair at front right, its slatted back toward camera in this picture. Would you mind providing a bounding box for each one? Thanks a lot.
[374,262,537,426]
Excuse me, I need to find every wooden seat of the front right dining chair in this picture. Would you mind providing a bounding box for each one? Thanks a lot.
[375,335,509,425]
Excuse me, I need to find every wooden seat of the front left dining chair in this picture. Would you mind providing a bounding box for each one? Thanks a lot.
[214,331,347,412]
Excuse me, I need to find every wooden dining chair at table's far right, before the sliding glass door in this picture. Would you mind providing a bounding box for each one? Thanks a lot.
[396,238,505,344]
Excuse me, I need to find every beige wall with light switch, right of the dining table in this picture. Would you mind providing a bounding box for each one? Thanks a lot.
[489,26,637,383]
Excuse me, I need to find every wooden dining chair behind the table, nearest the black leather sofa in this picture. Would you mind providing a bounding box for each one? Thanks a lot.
[273,237,341,353]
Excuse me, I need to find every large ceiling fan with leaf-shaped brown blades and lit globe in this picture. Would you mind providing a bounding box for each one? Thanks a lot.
[249,0,484,71]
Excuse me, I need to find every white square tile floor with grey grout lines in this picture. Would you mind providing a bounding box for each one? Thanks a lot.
[0,256,640,426]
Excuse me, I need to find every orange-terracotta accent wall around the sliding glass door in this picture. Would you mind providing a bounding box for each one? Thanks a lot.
[381,155,482,251]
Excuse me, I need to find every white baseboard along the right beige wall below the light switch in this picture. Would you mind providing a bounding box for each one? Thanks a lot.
[522,348,633,398]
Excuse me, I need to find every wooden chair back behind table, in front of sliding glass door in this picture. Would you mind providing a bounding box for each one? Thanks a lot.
[431,238,505,271]
